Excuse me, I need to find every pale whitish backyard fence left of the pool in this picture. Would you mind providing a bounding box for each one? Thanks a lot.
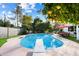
[0,27,20,38]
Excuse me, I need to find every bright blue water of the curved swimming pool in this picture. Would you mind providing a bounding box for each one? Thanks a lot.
[20,33,63,48]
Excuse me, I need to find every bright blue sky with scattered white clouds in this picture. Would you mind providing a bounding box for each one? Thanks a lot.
[0,3,45,25]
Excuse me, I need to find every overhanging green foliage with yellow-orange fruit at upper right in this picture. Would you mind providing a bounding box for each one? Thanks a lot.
[42,3,79,24]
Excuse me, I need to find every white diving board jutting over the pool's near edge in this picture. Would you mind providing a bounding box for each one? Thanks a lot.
[33,39,46,56]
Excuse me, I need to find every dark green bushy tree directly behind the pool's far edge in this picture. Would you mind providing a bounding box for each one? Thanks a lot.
[32,18,51,33]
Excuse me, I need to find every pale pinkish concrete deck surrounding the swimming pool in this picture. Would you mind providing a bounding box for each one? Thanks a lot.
[0,35,79,56]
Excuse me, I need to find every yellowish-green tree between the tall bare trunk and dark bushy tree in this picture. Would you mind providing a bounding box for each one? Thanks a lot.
[20,15,32,34]
